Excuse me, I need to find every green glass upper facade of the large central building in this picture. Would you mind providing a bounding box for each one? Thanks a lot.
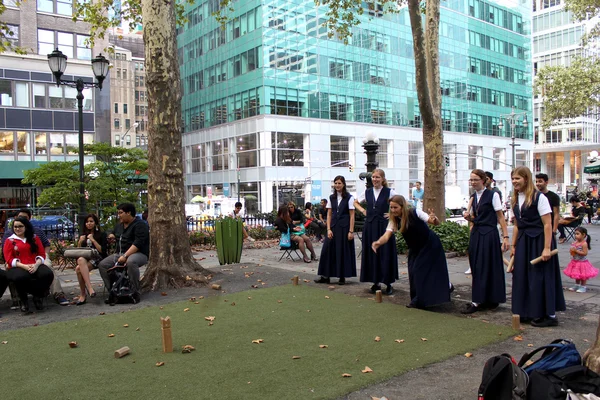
[178,0,532,139]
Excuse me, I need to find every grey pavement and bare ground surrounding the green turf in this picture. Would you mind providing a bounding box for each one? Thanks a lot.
[0,220,600,400]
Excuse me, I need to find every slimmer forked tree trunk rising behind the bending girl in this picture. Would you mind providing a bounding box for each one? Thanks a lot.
[408,0,446,221]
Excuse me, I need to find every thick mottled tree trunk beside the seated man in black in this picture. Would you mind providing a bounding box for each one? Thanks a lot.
[142,0,205,290]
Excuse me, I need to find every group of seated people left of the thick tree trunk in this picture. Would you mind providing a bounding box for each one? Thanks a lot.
[0,203,150,313]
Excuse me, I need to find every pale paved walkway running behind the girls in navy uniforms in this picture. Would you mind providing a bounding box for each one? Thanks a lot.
[34,219,600,305]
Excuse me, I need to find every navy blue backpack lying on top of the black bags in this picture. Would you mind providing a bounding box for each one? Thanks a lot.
[519,339,581,375]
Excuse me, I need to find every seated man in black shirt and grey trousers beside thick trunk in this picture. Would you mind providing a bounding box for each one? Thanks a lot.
[98,203,150,304]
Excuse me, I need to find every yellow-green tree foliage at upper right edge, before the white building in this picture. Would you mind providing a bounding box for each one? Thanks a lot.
[534,0,600,128]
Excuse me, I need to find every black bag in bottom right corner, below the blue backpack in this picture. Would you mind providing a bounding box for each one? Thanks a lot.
[527,365,600,400]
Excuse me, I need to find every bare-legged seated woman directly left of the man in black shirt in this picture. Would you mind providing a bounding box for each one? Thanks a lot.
[75,214,108,306]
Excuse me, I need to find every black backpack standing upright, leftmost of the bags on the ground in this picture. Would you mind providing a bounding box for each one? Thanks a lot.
[477,354,529,400]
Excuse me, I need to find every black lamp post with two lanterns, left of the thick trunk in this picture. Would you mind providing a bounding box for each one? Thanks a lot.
[48,48,109,232]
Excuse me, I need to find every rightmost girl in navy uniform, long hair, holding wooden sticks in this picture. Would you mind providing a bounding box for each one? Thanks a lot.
[511,167,566,327]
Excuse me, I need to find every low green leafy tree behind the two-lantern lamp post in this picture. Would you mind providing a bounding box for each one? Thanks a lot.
[23,143,148,219]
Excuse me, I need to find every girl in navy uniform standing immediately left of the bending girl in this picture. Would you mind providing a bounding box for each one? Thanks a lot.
[354,169,398,295]
